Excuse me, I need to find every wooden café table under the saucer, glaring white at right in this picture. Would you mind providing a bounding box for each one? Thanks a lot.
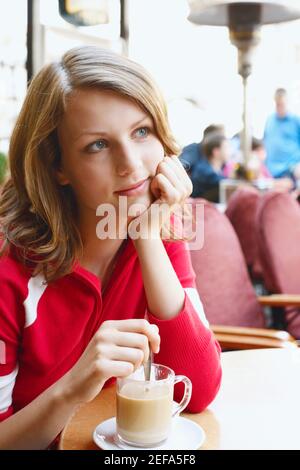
[60,349,300,450]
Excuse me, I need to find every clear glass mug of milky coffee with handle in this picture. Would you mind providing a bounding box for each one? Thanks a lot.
[116,364,192,447]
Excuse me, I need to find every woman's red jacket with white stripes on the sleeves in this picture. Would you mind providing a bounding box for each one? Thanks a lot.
[0,239,221,421]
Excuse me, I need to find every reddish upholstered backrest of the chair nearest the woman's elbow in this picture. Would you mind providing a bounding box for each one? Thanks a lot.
[191,199,265,327]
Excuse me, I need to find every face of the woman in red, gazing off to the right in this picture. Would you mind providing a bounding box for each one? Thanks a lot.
[58,89,164,214]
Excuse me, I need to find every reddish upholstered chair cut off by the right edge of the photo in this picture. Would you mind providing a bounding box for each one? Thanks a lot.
[258,192,300,338]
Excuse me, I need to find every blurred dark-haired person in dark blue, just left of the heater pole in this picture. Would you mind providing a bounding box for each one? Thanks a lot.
[192,132,231,202]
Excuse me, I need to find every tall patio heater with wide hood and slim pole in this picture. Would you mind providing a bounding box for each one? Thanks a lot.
[188,0,300,174]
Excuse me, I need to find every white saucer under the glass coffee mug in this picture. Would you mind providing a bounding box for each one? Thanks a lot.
[93,416,205,450]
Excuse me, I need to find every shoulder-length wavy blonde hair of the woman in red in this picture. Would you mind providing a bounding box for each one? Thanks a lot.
[0,46,186,282]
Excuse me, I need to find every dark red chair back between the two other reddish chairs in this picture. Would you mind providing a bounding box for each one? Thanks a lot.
[225,187,262,280]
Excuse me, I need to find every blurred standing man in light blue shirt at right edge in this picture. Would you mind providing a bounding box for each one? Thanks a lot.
[264,88,300,178]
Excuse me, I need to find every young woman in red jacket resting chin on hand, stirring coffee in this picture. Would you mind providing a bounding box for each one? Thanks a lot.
[0,47,221,449]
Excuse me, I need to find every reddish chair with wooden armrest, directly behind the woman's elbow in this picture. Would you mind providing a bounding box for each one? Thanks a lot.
[190,199,293,349]
